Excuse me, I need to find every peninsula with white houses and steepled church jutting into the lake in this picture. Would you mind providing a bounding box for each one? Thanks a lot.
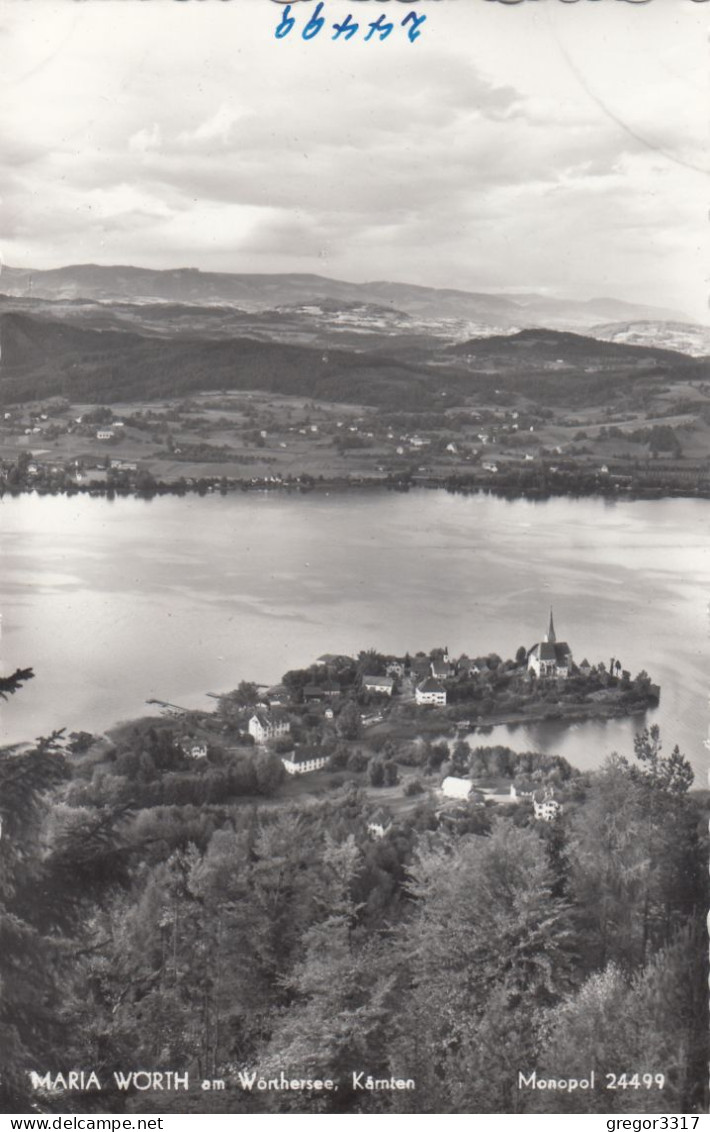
[52,610,660,813]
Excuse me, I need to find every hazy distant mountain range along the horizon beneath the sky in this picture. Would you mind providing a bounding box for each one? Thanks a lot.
[0,264,688,333]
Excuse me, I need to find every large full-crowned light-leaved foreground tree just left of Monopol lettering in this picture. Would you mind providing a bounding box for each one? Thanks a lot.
[392,821,573,1113]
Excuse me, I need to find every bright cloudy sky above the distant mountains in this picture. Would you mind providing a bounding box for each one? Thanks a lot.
[0,0,710,319]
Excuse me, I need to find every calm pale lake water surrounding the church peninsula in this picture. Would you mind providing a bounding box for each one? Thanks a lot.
[0,491,710,784]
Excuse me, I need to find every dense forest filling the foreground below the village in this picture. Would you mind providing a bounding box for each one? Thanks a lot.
[0,697,708,1113]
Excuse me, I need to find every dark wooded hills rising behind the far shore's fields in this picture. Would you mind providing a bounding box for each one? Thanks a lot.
[0,310,708,409]
